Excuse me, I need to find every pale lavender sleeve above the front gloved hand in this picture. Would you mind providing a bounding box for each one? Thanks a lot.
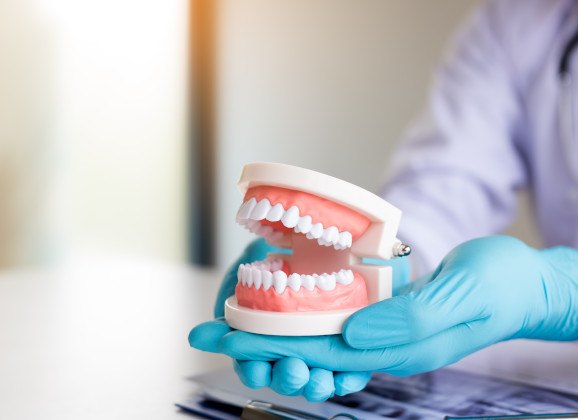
[383,2,526,275]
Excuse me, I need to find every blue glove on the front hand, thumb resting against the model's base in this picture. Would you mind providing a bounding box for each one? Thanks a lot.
[190,236,578,398]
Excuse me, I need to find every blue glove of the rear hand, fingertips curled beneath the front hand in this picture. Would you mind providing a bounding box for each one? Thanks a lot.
[198,239,374,401]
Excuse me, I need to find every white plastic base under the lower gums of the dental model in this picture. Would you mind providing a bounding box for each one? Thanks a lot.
[225,296,359,336]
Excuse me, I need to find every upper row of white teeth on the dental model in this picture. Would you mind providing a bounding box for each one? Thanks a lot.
[237,198,353,250]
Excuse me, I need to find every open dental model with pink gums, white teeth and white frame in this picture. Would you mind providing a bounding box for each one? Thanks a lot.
[225,163,410,336]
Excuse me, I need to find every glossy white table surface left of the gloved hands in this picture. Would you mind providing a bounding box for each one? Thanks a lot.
[0,261,228,420]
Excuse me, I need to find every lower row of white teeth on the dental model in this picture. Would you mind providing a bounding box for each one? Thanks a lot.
[237,262,353,294]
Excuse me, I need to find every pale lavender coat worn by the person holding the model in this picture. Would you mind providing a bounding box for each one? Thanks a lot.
[383,0,578,274]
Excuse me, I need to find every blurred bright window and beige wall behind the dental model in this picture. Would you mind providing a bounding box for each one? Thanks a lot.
[0,0,537,268]
